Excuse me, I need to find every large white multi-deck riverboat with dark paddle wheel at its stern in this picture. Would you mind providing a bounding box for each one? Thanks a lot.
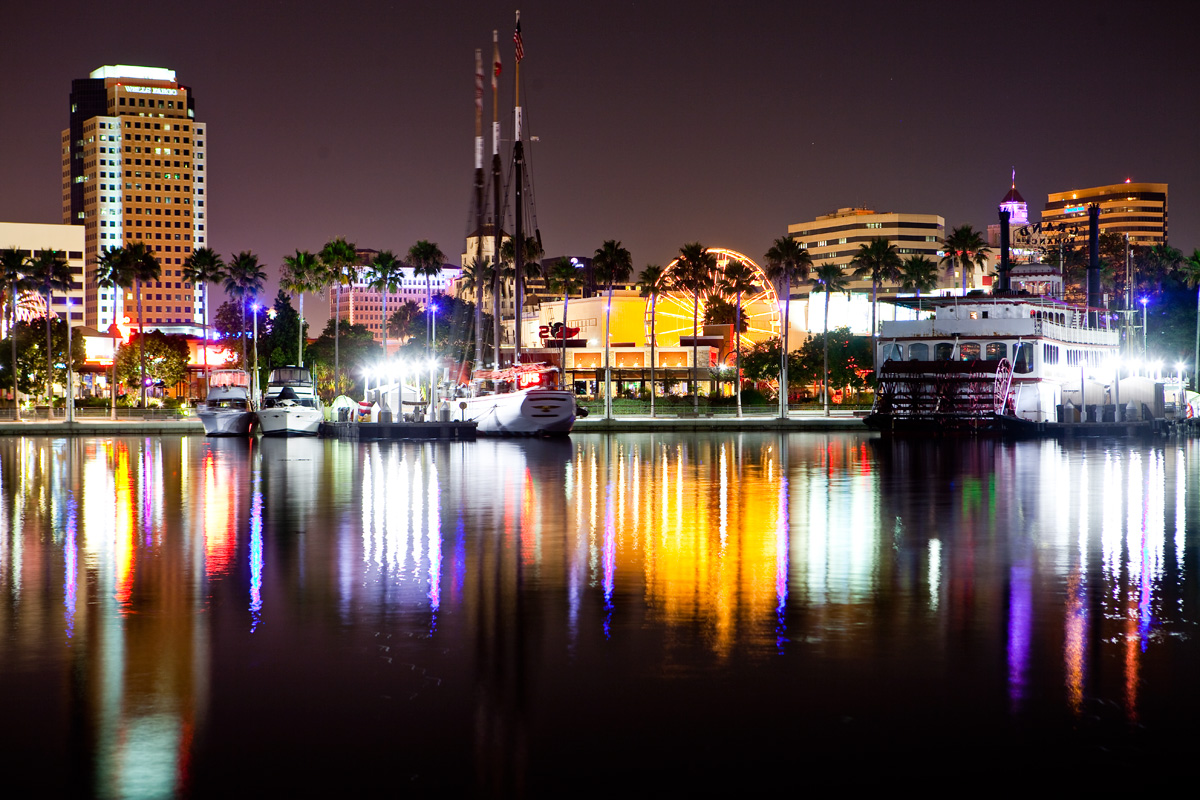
[868,294,1118,433]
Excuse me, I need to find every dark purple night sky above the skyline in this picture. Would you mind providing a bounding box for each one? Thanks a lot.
[0,0,1200,321]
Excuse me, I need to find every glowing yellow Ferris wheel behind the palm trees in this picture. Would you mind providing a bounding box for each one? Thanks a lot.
[646,247,780,347]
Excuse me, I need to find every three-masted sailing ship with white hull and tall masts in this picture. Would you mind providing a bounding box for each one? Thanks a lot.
[457,11,576,435]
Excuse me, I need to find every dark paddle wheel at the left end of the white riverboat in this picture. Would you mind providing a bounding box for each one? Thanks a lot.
[868,359,1013,433]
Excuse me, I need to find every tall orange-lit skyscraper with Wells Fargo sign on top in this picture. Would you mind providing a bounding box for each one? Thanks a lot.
[62,65,208,336]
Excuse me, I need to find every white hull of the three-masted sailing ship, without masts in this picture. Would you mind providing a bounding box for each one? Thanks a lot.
[450,363,576,437]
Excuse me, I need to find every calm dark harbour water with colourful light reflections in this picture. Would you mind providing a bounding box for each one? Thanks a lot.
[0,434,1200,798]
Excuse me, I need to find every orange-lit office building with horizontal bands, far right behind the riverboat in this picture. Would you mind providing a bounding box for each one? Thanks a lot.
[1042,181,1166,245]
